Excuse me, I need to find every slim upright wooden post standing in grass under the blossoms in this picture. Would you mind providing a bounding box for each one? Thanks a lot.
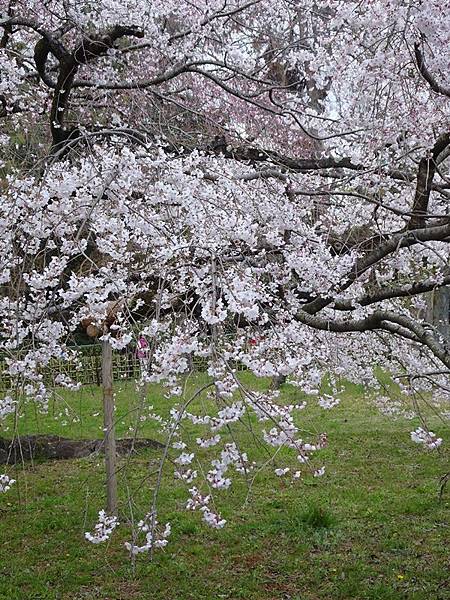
[102,340,117,515]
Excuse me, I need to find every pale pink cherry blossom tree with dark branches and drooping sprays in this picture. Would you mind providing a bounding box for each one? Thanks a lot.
[0,0,450,554]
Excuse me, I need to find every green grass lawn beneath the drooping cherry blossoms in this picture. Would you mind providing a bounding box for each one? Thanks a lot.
[0,374,450,600]
